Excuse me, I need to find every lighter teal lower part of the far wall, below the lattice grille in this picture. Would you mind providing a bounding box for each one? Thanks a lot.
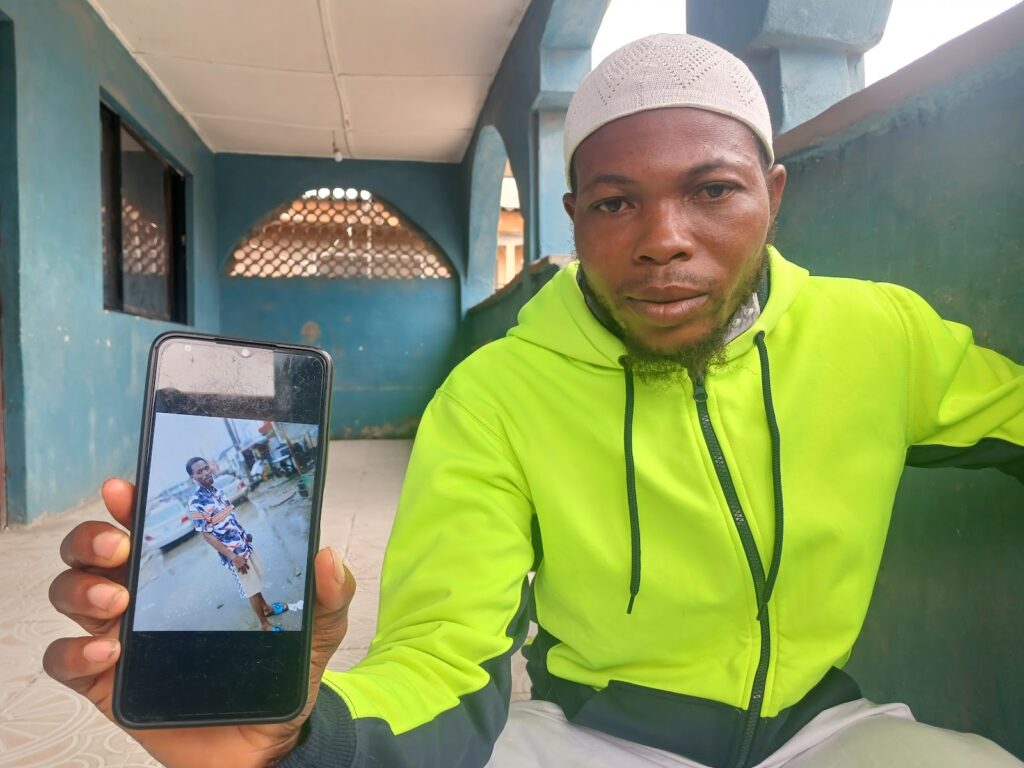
[221,278,459,438]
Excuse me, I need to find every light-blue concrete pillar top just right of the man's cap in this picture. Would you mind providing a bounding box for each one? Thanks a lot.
[686,0,892,133]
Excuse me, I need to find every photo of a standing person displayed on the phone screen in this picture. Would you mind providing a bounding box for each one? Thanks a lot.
[133,413,318,632]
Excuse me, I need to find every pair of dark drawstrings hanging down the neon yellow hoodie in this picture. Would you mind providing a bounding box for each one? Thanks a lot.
[618,331,784,622]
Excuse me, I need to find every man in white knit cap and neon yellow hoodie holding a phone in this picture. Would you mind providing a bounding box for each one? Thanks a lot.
[47,36,1024,768]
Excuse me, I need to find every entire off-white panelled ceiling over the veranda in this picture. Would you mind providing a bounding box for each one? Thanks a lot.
[89,0,529,163]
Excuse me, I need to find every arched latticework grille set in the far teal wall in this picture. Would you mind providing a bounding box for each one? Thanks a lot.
[234,188,453,280]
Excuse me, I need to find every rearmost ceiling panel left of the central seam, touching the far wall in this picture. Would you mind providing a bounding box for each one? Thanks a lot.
[194,116,333,158]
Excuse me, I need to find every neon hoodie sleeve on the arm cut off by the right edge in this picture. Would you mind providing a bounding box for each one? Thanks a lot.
[884,286,1024,482]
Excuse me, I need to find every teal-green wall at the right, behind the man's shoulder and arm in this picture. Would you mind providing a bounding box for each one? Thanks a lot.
[777,47,1024,757]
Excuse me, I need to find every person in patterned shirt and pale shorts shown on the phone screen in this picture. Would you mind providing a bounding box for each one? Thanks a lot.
[185,456,288,632]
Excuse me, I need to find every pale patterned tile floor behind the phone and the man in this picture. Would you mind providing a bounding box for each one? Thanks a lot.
[0,440,528,768]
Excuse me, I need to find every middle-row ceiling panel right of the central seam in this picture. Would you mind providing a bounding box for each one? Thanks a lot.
[340,77,490,131]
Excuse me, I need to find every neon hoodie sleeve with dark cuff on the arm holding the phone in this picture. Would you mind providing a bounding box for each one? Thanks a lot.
[282,390,534,768]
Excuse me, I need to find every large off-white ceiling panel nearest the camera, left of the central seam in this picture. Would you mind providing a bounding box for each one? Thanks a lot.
[90,0,331,72]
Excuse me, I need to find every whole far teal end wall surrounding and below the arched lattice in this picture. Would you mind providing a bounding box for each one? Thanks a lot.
[216,155,466,437]
